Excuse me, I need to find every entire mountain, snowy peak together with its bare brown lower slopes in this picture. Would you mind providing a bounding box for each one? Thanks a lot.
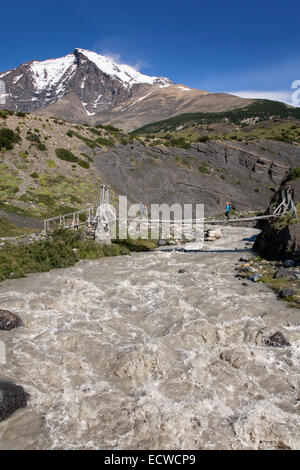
[0,48,252,132]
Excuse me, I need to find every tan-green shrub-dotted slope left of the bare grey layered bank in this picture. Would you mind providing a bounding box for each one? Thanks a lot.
[0,111,142,219]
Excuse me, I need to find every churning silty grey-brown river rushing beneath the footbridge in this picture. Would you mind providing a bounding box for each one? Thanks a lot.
[0,227,300,449]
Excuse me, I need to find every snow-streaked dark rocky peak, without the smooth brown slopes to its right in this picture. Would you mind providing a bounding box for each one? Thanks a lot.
[0,49,172,116]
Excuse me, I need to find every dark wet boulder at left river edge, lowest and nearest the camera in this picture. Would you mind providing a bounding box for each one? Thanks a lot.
[0,381,29,421]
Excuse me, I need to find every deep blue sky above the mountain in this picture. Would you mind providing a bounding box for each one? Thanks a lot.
[0,0,300,102]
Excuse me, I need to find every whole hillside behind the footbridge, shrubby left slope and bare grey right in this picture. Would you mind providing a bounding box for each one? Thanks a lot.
[0,104,300,236]
